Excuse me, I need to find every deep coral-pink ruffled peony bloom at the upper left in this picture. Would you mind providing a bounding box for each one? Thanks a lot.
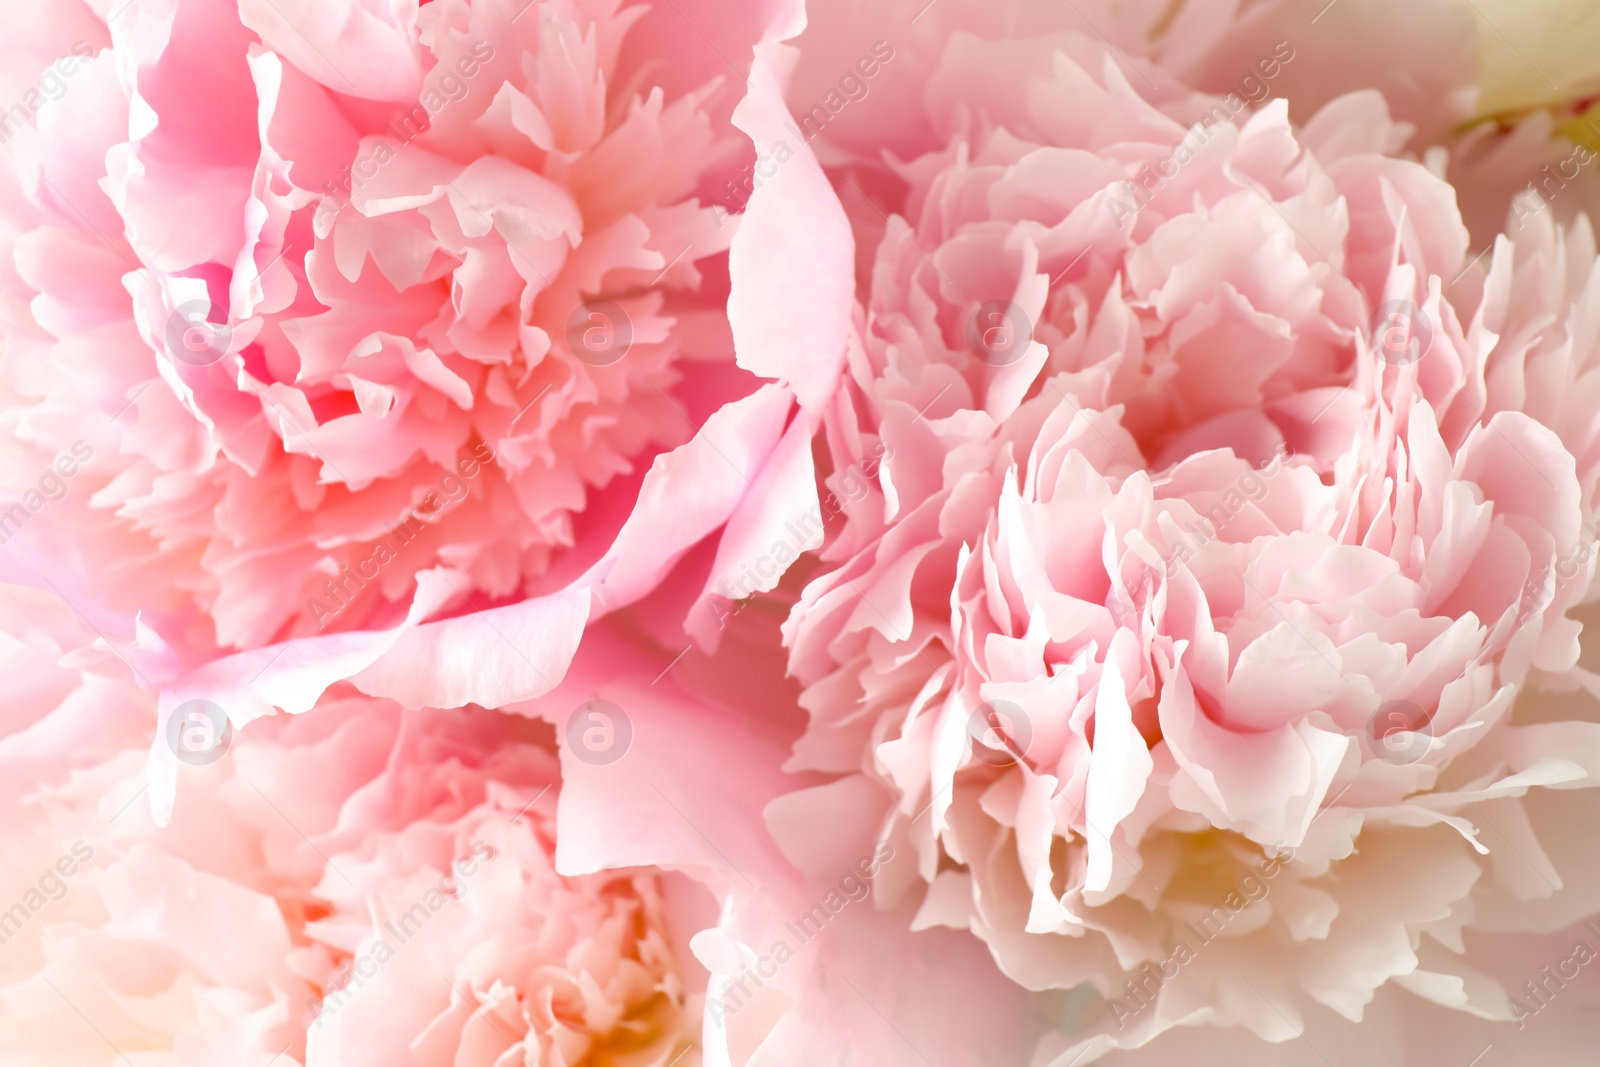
[0,0,787,656]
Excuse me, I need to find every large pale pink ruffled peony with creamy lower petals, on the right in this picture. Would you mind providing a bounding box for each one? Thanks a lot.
[752,8,1600,1064]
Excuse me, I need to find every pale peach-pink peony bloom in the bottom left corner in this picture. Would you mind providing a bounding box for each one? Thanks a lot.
[0,585,709,1065]
